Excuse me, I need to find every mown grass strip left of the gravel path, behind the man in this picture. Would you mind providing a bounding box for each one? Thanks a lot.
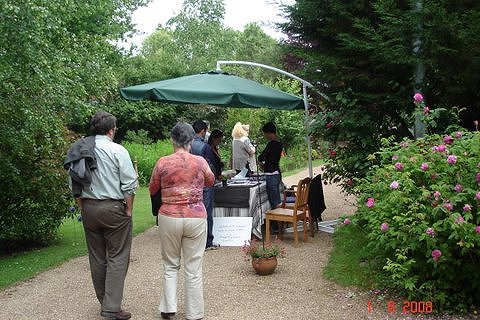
[0,187,155,289]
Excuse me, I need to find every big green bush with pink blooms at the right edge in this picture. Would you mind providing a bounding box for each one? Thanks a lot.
[349,129,480,306]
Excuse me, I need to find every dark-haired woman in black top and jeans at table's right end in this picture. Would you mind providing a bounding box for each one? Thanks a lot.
[258,122,283,233]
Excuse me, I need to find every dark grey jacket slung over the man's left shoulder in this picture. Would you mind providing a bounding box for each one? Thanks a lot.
[63,136,97,198]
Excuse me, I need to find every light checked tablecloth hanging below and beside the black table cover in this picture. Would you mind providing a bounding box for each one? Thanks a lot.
[213,181,270,239]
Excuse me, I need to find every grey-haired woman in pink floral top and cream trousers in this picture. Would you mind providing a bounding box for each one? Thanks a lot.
[149,122,215,319]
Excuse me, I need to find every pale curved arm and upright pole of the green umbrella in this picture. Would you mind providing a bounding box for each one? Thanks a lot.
[217,60,313,178]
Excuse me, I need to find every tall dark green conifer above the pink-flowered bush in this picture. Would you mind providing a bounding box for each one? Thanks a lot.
[281,0,480,189]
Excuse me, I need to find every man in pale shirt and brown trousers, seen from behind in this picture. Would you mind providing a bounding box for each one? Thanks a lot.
[72,111,138,320]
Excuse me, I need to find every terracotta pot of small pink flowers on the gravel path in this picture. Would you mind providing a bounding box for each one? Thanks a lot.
[242,239,285,276]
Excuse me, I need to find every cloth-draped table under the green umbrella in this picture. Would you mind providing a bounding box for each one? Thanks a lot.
[213,181,270,239]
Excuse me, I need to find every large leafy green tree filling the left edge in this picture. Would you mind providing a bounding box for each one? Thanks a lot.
[0,0,145,252]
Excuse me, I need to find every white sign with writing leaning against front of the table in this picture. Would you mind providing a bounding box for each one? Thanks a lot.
[213,217,252,247]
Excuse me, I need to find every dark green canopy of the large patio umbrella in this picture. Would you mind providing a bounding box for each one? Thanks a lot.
[120,71,304,110]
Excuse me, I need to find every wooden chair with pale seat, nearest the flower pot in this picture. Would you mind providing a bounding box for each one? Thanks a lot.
[265,178,311,247]
